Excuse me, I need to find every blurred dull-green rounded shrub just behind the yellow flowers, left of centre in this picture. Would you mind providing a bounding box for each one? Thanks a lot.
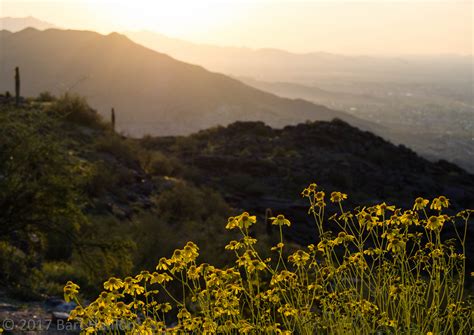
[132,184,230,269]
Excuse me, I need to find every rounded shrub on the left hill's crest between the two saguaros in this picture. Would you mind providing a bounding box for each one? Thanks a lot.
[49,93,105,128]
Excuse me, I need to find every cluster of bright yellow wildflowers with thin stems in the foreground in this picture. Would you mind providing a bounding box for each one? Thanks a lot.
[64,184,473,334]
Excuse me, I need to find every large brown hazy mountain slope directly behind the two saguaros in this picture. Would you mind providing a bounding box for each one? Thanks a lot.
[0,28,370,136]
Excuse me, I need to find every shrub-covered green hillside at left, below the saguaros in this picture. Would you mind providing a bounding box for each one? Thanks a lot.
[0,94,230,298]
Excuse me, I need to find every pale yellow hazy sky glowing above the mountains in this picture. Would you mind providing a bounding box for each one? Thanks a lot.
[0,0,474,55]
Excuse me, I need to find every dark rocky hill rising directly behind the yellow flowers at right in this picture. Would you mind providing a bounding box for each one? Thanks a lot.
[142,120,474,249]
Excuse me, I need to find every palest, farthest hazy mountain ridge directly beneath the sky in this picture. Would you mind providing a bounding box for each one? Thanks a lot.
[125,31,472,84]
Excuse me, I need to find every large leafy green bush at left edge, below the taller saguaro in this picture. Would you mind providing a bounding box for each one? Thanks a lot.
[0,110,85,236]
